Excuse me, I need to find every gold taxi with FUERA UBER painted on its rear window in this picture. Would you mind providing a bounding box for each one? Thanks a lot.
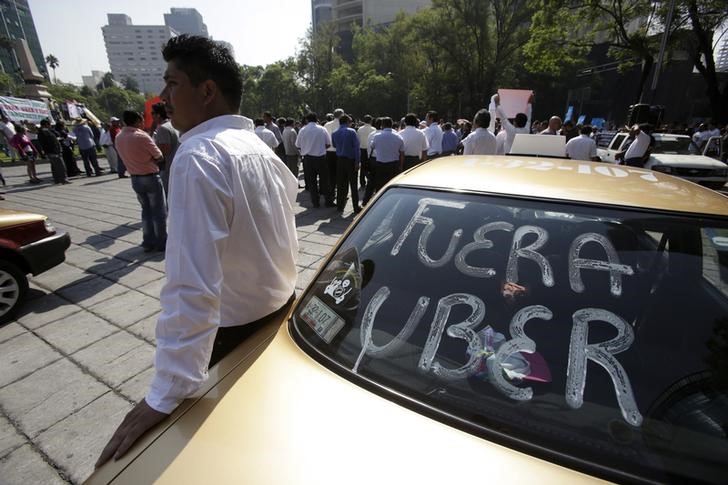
[88,156,728,484]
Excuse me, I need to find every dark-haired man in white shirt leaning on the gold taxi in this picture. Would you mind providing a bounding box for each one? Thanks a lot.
[97,35,298,466]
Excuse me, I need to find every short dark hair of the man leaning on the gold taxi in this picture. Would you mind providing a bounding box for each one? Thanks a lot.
[162,34,243,113]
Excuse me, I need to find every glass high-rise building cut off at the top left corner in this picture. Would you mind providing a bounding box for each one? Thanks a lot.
[0,0,48,77]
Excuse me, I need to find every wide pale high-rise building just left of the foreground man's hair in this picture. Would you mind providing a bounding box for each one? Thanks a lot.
[101,13,177,94]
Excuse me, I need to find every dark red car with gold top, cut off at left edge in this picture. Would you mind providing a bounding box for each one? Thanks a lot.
[0,209,71,324]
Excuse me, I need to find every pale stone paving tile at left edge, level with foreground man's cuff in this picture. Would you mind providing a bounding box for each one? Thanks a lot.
[0,359,109,439]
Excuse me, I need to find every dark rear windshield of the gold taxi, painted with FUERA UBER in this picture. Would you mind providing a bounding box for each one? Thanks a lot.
[293,187,728,483]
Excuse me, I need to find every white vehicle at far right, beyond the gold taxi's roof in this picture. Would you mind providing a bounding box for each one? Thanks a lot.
[597,133,728,189]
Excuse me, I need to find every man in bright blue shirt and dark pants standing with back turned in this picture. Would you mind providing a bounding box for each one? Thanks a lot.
[331,115,361,214]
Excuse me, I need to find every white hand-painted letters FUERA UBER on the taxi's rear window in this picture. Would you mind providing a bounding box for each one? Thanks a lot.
[353,198,642,426]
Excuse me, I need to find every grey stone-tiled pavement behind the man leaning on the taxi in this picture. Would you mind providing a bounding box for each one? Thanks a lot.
[0,161,352,485]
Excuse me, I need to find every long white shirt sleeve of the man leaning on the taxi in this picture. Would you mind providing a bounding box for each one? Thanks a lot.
[146,153,233,414]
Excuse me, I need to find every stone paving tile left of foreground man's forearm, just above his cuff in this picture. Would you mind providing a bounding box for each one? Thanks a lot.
[71,332,154,387]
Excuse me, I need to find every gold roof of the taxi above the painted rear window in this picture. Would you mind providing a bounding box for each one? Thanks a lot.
[392,155,728,216]
